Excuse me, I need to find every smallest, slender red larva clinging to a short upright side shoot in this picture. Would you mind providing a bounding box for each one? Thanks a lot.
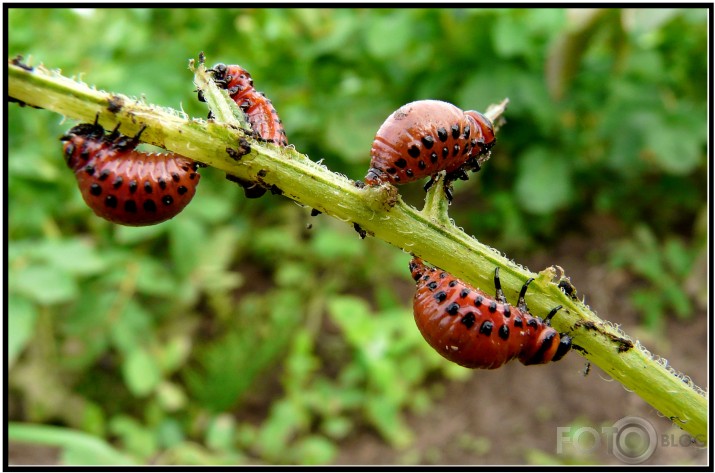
[211,63,288,146]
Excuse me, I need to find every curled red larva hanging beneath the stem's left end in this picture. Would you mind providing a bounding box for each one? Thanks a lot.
[61,123,200,226]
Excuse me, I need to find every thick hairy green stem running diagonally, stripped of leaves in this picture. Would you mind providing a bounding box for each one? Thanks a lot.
[8,60,707,442]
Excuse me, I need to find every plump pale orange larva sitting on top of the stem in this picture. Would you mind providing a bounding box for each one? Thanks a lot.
[365,100,495,185]
